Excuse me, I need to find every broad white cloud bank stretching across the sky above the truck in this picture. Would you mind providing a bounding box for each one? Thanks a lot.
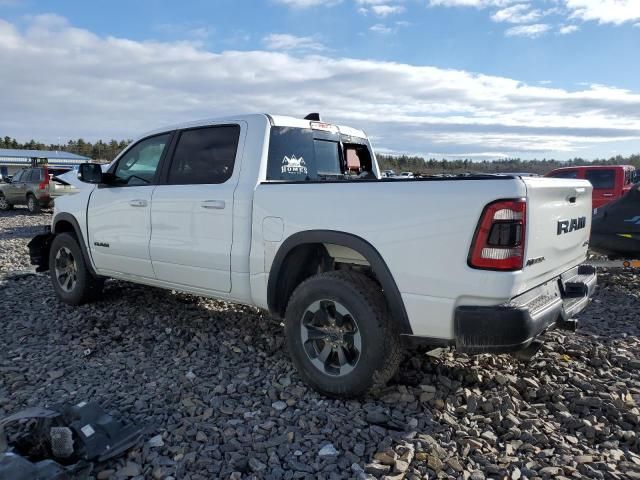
[0,15,640,157]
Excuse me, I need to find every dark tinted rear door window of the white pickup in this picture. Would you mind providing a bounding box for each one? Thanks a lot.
[168,125,240,185]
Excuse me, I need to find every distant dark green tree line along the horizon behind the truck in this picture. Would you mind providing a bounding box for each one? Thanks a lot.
[0,136,640,174]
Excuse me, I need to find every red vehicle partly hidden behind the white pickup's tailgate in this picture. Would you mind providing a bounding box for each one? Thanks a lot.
[545,165,636,209]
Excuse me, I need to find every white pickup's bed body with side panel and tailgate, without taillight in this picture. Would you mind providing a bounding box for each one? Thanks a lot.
[252,175,591,339]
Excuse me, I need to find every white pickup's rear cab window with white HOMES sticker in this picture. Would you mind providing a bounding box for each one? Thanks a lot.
[267,127,376,182]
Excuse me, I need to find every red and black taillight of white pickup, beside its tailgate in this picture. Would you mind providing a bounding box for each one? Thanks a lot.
[468,198,527,271]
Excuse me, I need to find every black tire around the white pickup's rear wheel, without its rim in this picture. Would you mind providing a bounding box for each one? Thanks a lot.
[285,270,402,397]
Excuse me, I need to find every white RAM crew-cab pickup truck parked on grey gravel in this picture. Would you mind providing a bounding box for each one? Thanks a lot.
[30,114,596,396]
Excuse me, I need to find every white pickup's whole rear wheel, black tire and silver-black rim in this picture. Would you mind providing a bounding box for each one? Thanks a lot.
[285,270,402,397]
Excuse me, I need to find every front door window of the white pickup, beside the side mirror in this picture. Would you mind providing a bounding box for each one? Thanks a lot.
[113,133,171,186]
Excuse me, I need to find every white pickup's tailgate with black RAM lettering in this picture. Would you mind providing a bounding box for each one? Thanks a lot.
[521,177,592,291]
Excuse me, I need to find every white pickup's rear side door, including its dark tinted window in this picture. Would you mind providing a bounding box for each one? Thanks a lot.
[149,125,245,293]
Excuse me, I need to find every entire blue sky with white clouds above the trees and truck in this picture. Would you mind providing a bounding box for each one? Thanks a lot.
[0,0,640,158]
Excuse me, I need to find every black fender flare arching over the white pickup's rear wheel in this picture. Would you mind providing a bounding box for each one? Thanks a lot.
[267,230,413,335]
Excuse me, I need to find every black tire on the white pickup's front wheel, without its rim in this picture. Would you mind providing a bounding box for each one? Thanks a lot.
[49,233,104,305]
